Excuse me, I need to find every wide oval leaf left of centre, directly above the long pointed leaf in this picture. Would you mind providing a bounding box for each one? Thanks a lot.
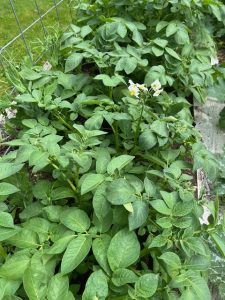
[60,207,90,232]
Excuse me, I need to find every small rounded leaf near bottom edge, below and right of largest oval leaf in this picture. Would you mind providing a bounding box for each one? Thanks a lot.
[135,274,158,299]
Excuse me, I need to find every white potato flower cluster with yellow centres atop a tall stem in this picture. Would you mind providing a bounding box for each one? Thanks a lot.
[128,79,163,98]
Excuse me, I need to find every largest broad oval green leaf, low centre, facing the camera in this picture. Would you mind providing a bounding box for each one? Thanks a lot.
[107,229,140,271]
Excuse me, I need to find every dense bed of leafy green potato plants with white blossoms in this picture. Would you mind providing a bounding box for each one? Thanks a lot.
[0,0,225,300]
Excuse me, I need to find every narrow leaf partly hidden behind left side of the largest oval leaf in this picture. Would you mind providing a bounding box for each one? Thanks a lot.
[92,234,111,274]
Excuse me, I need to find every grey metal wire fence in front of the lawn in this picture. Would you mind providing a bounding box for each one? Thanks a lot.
[0,0,73,61]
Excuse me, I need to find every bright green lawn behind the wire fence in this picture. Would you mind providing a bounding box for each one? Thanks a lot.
[0,0,72,97]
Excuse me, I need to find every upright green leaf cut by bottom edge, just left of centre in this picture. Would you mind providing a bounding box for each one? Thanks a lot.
[82,270,108,300]
